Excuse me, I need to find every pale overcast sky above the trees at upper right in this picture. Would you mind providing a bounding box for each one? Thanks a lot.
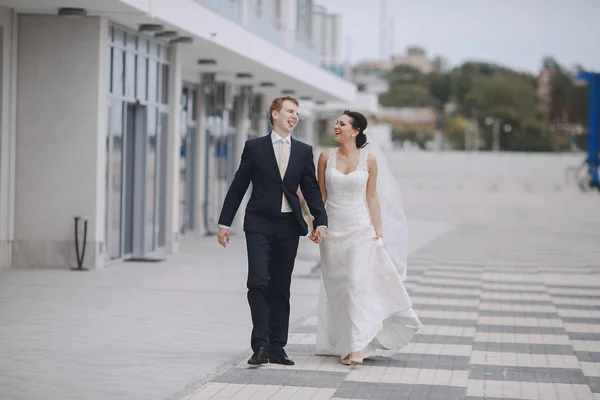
[317,0,600,72]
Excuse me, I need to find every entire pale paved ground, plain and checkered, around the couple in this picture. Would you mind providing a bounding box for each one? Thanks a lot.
[0,154,600,400]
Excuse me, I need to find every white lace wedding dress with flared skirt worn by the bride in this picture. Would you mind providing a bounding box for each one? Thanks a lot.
[317,149,422,358]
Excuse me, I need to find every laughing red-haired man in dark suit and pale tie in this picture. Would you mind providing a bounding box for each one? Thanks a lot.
[218,96,327,365]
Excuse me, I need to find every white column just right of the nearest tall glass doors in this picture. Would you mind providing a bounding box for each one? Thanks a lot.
[165,44,182,253]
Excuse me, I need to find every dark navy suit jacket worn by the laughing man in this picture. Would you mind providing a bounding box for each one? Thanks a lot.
[219,134,327,236]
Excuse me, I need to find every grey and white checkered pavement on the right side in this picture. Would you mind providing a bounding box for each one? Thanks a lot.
[178,229,600,400]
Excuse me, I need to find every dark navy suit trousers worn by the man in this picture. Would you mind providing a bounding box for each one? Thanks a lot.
[246,213,300,351]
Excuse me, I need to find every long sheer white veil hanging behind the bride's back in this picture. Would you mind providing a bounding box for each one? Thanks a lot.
[364,136,408,281]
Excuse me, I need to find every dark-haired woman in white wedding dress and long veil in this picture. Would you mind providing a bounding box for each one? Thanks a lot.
[311,111,422,365]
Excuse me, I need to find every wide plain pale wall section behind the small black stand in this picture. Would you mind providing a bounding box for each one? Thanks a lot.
[13,15,108,268]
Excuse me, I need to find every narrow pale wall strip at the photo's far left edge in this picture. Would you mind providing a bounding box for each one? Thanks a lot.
[0,7,17,268]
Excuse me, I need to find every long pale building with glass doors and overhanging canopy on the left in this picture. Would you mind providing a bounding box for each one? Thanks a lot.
[0,0,355,269]
